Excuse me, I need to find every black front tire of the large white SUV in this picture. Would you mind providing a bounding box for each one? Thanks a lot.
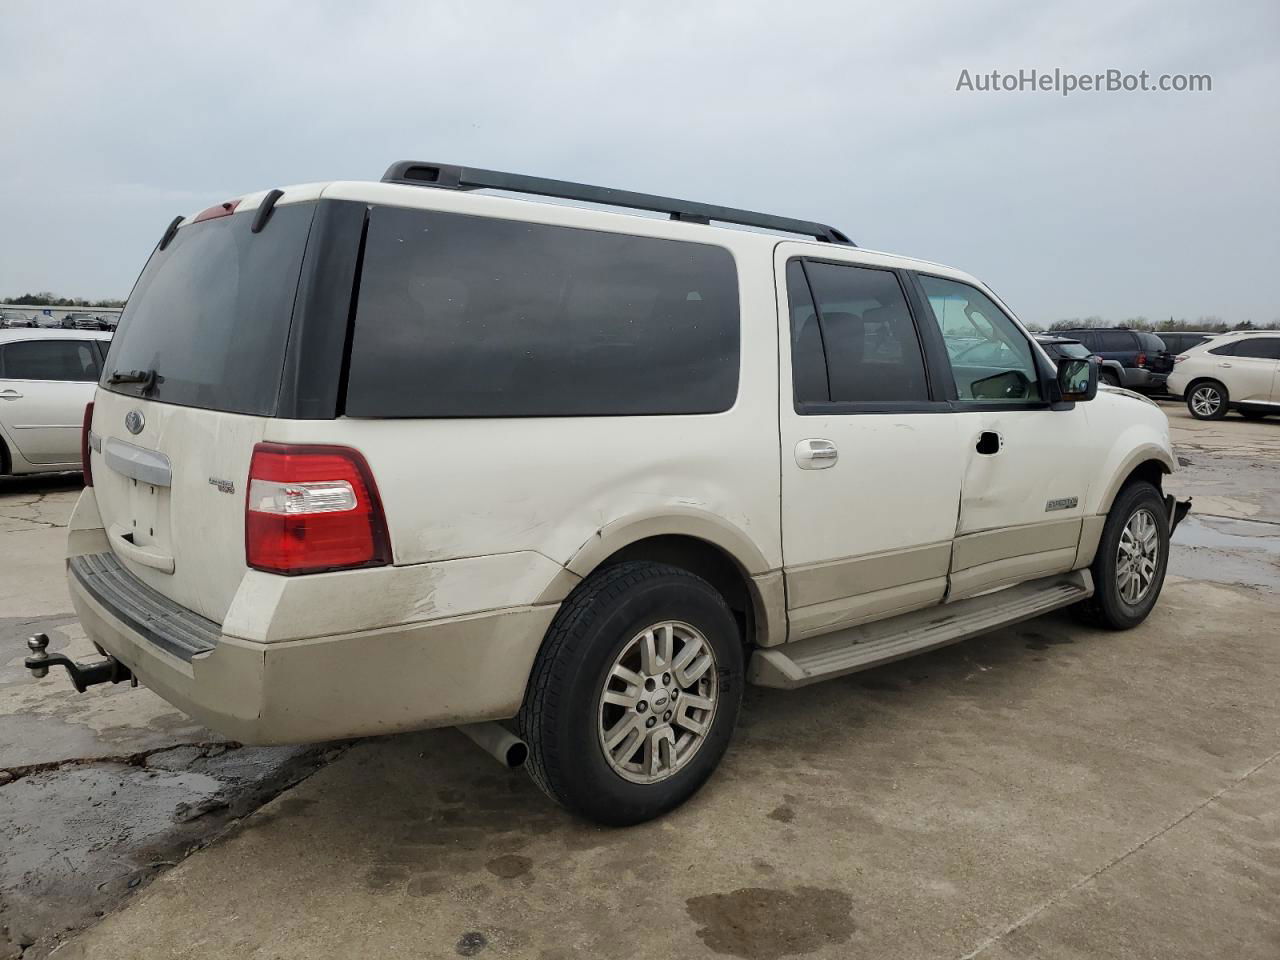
[1079,481,1169,630]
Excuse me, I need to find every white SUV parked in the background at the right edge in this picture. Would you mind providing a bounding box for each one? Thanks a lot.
[1166,330,1280,420]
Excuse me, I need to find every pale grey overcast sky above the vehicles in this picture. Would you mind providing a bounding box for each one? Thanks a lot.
[0,0,1280,323]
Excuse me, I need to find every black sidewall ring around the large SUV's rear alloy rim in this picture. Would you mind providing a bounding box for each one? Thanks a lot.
[543,570,745,826]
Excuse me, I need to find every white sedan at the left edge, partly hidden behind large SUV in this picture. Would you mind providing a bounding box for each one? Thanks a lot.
[0,329,111,475]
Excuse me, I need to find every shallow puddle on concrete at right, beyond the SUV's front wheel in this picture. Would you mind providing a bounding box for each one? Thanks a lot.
[1169,513,1280,588]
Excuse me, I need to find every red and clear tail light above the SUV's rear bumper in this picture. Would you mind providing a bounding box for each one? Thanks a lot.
[244,443,392,576]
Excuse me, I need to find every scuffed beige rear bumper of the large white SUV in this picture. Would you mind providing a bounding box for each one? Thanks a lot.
[68,558,558,744]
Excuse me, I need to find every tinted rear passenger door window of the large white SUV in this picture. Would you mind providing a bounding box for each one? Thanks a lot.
[787,260,929,403]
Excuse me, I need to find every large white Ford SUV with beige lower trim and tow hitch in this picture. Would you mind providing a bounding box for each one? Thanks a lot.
[28,163,1183,823]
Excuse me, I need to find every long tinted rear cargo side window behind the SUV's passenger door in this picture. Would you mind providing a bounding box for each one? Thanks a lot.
[346,207,740,417]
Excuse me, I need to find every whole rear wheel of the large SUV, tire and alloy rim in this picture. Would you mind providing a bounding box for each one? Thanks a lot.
[516,562,744,827]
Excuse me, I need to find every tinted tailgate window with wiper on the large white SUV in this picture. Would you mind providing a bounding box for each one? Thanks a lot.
[102,204,315,416]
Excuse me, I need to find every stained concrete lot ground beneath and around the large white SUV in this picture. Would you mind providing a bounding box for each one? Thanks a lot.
[0,406,1280,960]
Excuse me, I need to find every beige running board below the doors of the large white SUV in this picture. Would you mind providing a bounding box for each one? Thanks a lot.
[749,570,1093,690]
